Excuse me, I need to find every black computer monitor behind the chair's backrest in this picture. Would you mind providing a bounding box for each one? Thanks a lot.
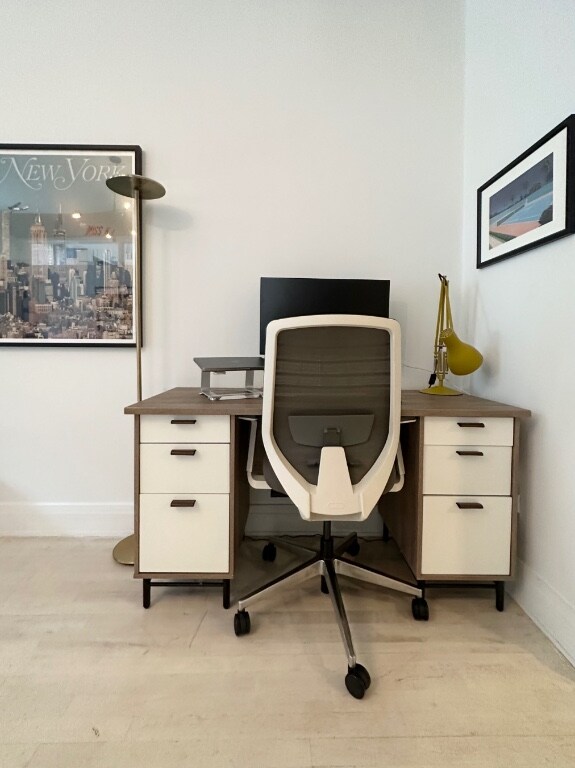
[260,277,389,355]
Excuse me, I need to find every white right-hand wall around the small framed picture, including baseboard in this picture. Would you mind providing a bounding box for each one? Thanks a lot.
[463,0,575,660]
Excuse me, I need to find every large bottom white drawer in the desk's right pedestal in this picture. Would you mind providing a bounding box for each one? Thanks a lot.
[421,496,511,576]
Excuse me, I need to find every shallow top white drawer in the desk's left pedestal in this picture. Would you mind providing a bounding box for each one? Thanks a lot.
[140,416,230,443]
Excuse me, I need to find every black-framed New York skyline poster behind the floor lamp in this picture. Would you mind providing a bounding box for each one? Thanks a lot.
[0,144,142,347]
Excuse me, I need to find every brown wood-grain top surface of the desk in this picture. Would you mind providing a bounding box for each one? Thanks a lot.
[124,387,531,418]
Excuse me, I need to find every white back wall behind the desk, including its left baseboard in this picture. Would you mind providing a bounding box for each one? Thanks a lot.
[0,0,463,535]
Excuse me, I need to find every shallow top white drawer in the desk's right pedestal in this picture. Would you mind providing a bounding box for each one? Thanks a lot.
[423,416,513,445]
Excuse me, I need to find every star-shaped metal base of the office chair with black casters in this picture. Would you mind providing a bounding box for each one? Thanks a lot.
[234,521,429,699]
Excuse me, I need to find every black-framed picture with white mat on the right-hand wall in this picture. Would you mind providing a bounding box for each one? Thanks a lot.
[477,115,575,269]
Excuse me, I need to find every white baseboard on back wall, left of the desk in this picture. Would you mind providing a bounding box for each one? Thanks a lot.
[0,502,134,538]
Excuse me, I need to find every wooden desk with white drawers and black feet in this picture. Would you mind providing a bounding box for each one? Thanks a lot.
[124,387,531,610]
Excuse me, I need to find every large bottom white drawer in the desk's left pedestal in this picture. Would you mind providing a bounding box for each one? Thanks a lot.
[139,494,230,574]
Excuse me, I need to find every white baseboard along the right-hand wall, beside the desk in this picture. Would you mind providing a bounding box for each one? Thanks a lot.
[509,560,575,666]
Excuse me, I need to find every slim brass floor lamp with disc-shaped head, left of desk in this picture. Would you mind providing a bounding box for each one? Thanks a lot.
[106,173,166,565]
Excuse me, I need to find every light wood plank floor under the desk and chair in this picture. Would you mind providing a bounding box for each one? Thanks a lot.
[0,539,575,768]
